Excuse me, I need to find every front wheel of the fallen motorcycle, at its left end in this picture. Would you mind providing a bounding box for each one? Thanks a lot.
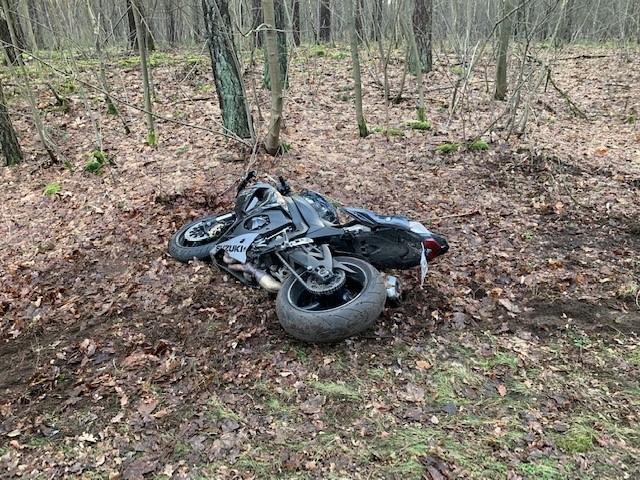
[169,215,233,262]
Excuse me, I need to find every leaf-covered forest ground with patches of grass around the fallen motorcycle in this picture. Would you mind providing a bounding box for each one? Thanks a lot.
[0,43,640,480]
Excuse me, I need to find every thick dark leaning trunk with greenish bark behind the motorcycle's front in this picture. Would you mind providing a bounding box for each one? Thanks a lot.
[202,0,255,139]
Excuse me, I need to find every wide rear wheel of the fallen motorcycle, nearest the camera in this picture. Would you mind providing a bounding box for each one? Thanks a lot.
[276,257,386,343]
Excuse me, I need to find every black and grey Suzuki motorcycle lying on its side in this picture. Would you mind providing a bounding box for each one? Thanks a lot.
[169,172,449,342]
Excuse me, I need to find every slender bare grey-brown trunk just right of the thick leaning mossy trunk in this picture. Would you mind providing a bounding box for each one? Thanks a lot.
[262,0,283,155]
